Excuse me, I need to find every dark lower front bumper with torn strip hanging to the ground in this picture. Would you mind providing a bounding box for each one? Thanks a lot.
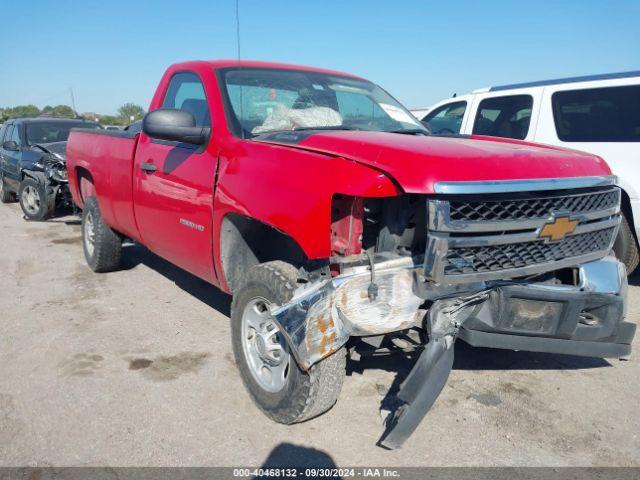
[379,257,636,448]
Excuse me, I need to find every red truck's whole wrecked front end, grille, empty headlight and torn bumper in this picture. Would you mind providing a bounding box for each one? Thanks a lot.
[272,182,635,448]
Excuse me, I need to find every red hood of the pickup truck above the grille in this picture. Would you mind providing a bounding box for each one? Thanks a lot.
[254,131,611,193]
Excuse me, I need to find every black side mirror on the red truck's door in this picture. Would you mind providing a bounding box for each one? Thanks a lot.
[142,108,211,145]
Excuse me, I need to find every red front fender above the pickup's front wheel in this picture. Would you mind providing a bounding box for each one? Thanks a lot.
[213,141,402,288]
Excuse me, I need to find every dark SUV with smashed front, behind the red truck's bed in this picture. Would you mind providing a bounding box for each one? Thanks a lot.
[0,117,101,220]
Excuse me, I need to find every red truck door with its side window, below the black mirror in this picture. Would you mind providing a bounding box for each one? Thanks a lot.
[133,72,216,281]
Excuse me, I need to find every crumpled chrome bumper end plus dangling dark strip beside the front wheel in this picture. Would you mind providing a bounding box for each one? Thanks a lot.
[272,253,489,448]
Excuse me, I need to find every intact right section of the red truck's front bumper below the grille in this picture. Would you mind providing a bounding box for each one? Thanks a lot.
[458,257,636,358]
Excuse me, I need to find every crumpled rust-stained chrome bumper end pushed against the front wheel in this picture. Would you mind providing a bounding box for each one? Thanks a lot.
[272,257,424,370]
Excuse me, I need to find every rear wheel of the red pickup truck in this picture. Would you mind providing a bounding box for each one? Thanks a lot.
[82,197,122,273]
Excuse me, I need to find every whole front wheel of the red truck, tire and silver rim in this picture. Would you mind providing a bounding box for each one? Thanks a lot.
[231,261,346,424]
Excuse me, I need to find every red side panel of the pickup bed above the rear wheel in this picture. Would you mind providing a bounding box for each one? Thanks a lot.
[67,128,139,240]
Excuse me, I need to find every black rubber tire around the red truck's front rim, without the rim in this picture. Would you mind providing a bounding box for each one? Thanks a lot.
[231,261,346,424]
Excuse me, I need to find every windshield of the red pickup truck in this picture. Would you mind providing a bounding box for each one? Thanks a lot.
[222,68,428,138]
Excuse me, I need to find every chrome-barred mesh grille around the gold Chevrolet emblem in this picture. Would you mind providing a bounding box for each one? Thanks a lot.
[425,185,620,284]
